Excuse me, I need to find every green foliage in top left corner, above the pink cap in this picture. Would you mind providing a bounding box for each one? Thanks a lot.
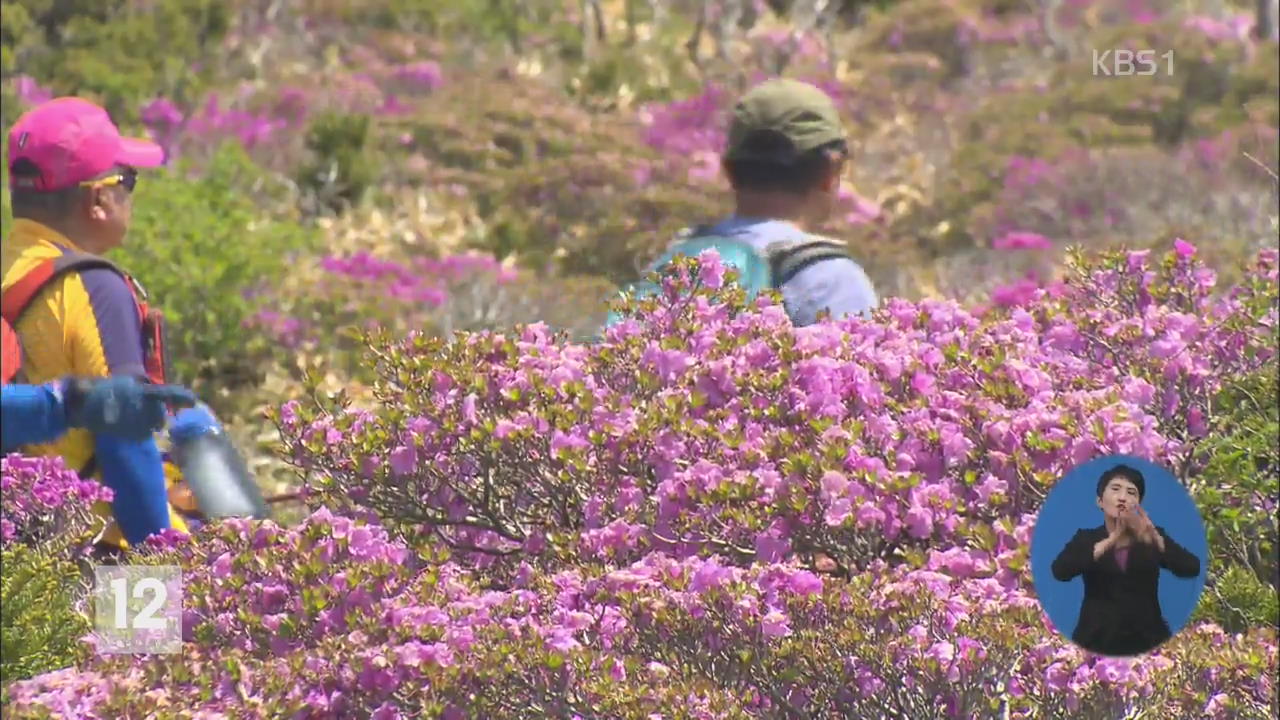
[0,0,232,122]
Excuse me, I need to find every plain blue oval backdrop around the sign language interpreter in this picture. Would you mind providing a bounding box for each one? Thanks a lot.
[1032,455,1210,639]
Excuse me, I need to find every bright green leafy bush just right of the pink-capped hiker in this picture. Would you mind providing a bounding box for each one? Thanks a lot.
[114,145,311,407]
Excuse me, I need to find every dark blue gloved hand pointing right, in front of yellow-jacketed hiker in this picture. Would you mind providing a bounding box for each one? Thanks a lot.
[63,377,198,441]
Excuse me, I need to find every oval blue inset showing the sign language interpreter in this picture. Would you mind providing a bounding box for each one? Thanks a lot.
[1030,455,1208,656]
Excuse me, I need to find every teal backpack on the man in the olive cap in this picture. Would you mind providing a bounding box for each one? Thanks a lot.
[604,228,849,328]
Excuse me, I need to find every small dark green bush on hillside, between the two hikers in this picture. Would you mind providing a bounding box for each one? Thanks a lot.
[298,113,376,211]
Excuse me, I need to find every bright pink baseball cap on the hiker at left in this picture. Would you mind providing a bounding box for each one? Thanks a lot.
[9,97,164,192]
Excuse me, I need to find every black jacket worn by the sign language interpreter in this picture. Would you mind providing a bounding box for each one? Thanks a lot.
[1053,525,1201,656]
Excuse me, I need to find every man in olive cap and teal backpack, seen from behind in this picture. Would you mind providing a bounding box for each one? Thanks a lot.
[605,79,878,327]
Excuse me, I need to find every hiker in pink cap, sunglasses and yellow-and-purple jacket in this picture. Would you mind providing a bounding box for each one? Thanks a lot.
[0,97,187,550]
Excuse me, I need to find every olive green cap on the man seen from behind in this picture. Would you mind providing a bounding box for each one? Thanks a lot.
[724,79,846,161]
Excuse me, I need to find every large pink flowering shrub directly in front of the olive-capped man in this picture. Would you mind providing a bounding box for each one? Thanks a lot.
[280,242,1276,571]
